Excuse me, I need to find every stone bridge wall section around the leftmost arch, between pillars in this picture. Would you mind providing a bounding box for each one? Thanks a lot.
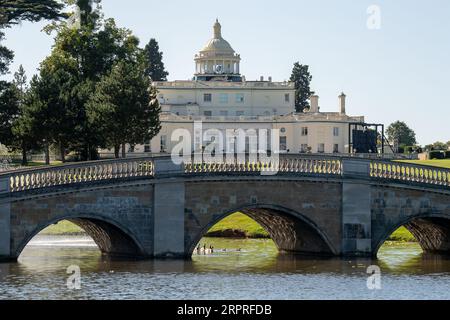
[11,184,153,257]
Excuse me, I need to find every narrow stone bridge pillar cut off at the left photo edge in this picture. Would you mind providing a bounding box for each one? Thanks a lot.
[0,176,11,261]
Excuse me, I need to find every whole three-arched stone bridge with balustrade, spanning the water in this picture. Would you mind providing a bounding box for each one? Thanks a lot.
[0,155,450,260]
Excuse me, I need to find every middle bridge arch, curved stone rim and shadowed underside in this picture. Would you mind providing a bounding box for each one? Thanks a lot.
[187,204,339,256]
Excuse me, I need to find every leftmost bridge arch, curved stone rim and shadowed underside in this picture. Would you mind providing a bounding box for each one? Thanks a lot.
[14,214,145,258]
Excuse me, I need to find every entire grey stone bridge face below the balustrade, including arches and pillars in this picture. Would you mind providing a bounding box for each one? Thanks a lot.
[0,170,450,260]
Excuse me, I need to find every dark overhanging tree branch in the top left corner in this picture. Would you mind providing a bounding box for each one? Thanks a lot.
[0,0,65,27]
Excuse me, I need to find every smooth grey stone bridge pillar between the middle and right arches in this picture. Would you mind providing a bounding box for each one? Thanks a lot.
[342,159,372,256]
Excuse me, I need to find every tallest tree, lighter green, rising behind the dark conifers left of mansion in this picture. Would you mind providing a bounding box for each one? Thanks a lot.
[42,0,146,160]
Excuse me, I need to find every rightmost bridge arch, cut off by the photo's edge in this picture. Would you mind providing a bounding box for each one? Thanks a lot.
[372,213,450,256]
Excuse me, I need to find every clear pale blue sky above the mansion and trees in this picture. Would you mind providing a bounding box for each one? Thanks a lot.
[4,0,450,145]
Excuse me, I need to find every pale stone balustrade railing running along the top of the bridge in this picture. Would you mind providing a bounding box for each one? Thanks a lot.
[0,154,450,195]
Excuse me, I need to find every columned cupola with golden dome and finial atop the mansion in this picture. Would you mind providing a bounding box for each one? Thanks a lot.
[194,20,242,81]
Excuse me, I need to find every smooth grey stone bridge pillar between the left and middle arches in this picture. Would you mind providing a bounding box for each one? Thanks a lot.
[153,158,185,258]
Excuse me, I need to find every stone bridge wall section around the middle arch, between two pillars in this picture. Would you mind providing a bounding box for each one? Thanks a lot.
[186,180,341,254]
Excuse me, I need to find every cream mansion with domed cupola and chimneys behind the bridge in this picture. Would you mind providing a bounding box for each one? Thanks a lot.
[120,21,364,153]
